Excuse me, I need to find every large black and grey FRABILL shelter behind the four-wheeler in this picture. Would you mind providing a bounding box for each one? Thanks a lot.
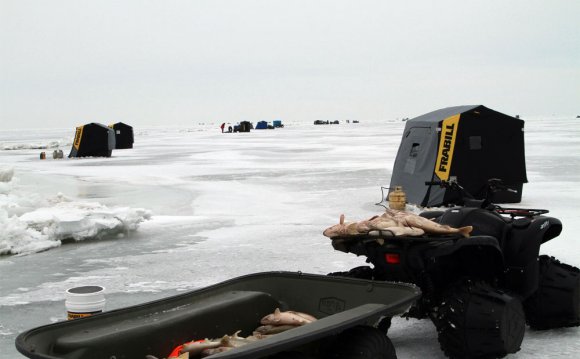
[390,105,527,206]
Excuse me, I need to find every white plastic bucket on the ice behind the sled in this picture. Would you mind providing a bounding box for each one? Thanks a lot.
[65,285,105,320]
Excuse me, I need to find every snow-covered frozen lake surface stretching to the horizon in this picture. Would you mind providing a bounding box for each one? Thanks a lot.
[0,117,580,358]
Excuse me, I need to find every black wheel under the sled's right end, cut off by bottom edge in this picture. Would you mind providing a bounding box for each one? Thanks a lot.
[327,326,397,359]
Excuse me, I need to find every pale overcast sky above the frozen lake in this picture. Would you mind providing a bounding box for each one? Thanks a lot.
[0,0,580,128]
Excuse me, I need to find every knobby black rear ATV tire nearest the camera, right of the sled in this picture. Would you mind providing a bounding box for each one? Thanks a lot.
[434,282,526,359]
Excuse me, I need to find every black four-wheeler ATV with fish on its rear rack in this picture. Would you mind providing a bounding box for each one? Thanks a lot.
[331,180,580,358]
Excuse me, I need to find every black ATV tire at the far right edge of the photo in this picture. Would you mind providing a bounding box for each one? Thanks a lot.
[524,256,580,330]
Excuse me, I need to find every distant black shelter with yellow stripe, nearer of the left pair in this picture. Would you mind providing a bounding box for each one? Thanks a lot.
[68,122,115,157]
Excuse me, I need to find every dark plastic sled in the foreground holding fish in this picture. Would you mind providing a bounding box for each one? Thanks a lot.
[16,272,420,359]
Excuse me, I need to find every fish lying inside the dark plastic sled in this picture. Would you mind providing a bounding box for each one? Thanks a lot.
[146,308,316,359]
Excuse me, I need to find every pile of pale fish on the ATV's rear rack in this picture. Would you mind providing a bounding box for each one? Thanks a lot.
[323,209,473,238]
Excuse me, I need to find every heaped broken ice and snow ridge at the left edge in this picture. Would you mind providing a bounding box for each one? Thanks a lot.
[0,168,151,255]
